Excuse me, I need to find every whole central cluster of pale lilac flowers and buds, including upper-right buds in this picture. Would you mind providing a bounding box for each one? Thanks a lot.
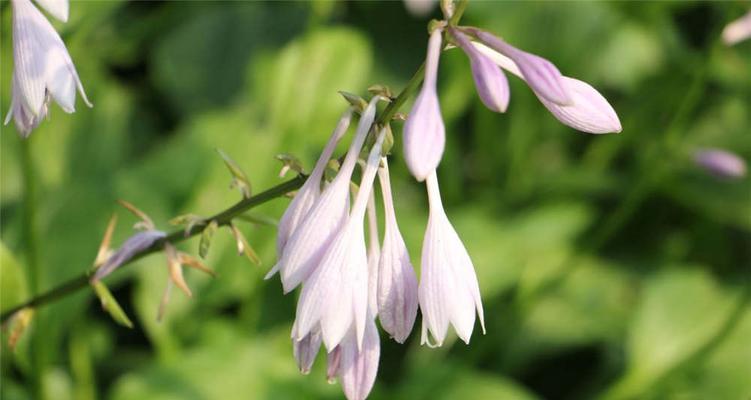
[266,23,621,399]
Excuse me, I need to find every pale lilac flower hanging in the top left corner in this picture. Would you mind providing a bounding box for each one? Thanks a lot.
[5,0,92,137]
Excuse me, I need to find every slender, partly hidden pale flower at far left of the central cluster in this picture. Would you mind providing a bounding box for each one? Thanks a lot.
[266,108,352,268]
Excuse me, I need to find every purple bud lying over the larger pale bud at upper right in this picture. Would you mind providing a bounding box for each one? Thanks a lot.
[474,30,572,105]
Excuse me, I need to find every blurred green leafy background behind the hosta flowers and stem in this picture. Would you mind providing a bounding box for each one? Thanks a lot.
[0,1,751,399]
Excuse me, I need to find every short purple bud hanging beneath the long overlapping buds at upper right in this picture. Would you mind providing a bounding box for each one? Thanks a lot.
[451,29,510,112]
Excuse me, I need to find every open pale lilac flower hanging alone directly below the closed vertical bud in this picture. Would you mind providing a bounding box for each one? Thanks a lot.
[419,173,485,346]
